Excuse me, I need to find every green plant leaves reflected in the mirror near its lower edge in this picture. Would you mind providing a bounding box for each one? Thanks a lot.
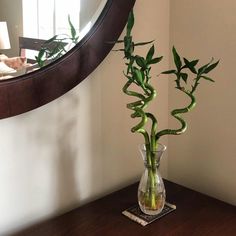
[35,16,79,68]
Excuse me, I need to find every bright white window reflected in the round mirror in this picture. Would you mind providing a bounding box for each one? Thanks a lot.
[22,0,80,58]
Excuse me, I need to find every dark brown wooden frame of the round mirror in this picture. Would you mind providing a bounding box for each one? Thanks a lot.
[0,0,135,119]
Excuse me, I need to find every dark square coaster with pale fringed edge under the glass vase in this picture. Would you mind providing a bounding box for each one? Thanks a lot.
[122,202,176,226]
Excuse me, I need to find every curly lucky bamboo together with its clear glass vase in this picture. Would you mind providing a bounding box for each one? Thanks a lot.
[114,12,219,215]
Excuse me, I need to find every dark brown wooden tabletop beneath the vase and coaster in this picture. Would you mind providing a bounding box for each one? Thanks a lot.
[12,181,236,236]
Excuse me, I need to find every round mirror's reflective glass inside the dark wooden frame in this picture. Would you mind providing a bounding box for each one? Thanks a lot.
[0,0,107,80]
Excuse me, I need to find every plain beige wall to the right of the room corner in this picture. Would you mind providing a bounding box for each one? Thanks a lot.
[168,0,236,204]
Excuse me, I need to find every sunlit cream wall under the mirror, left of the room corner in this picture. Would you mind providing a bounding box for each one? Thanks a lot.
[0,0,169,235]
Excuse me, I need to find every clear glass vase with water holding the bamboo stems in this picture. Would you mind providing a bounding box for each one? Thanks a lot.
[138,144,166,215]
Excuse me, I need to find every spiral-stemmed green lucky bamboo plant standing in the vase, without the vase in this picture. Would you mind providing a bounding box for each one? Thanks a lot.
[116,12,219,214]
